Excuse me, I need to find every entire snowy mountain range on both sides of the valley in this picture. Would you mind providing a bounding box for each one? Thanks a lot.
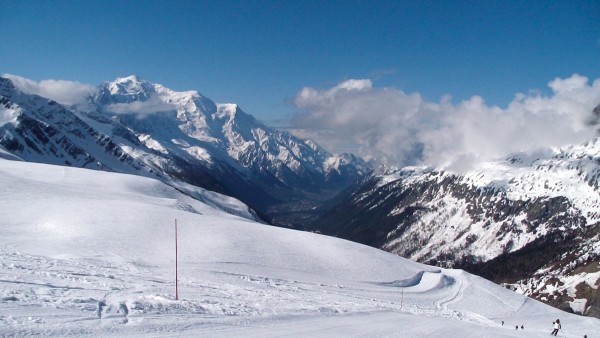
[0,76,600,317]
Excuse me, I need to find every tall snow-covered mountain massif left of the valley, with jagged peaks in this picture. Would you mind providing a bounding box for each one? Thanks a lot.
[0,76,370,226]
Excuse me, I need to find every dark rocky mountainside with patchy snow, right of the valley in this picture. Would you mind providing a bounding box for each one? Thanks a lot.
[313,139,600,316]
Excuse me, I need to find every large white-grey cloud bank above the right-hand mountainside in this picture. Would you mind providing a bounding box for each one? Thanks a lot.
[291,74,600,170]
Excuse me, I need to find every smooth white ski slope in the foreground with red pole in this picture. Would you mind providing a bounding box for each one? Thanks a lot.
[0,158,600,337]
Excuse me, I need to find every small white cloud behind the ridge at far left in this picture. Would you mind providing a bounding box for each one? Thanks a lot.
[2,74,96,105]
